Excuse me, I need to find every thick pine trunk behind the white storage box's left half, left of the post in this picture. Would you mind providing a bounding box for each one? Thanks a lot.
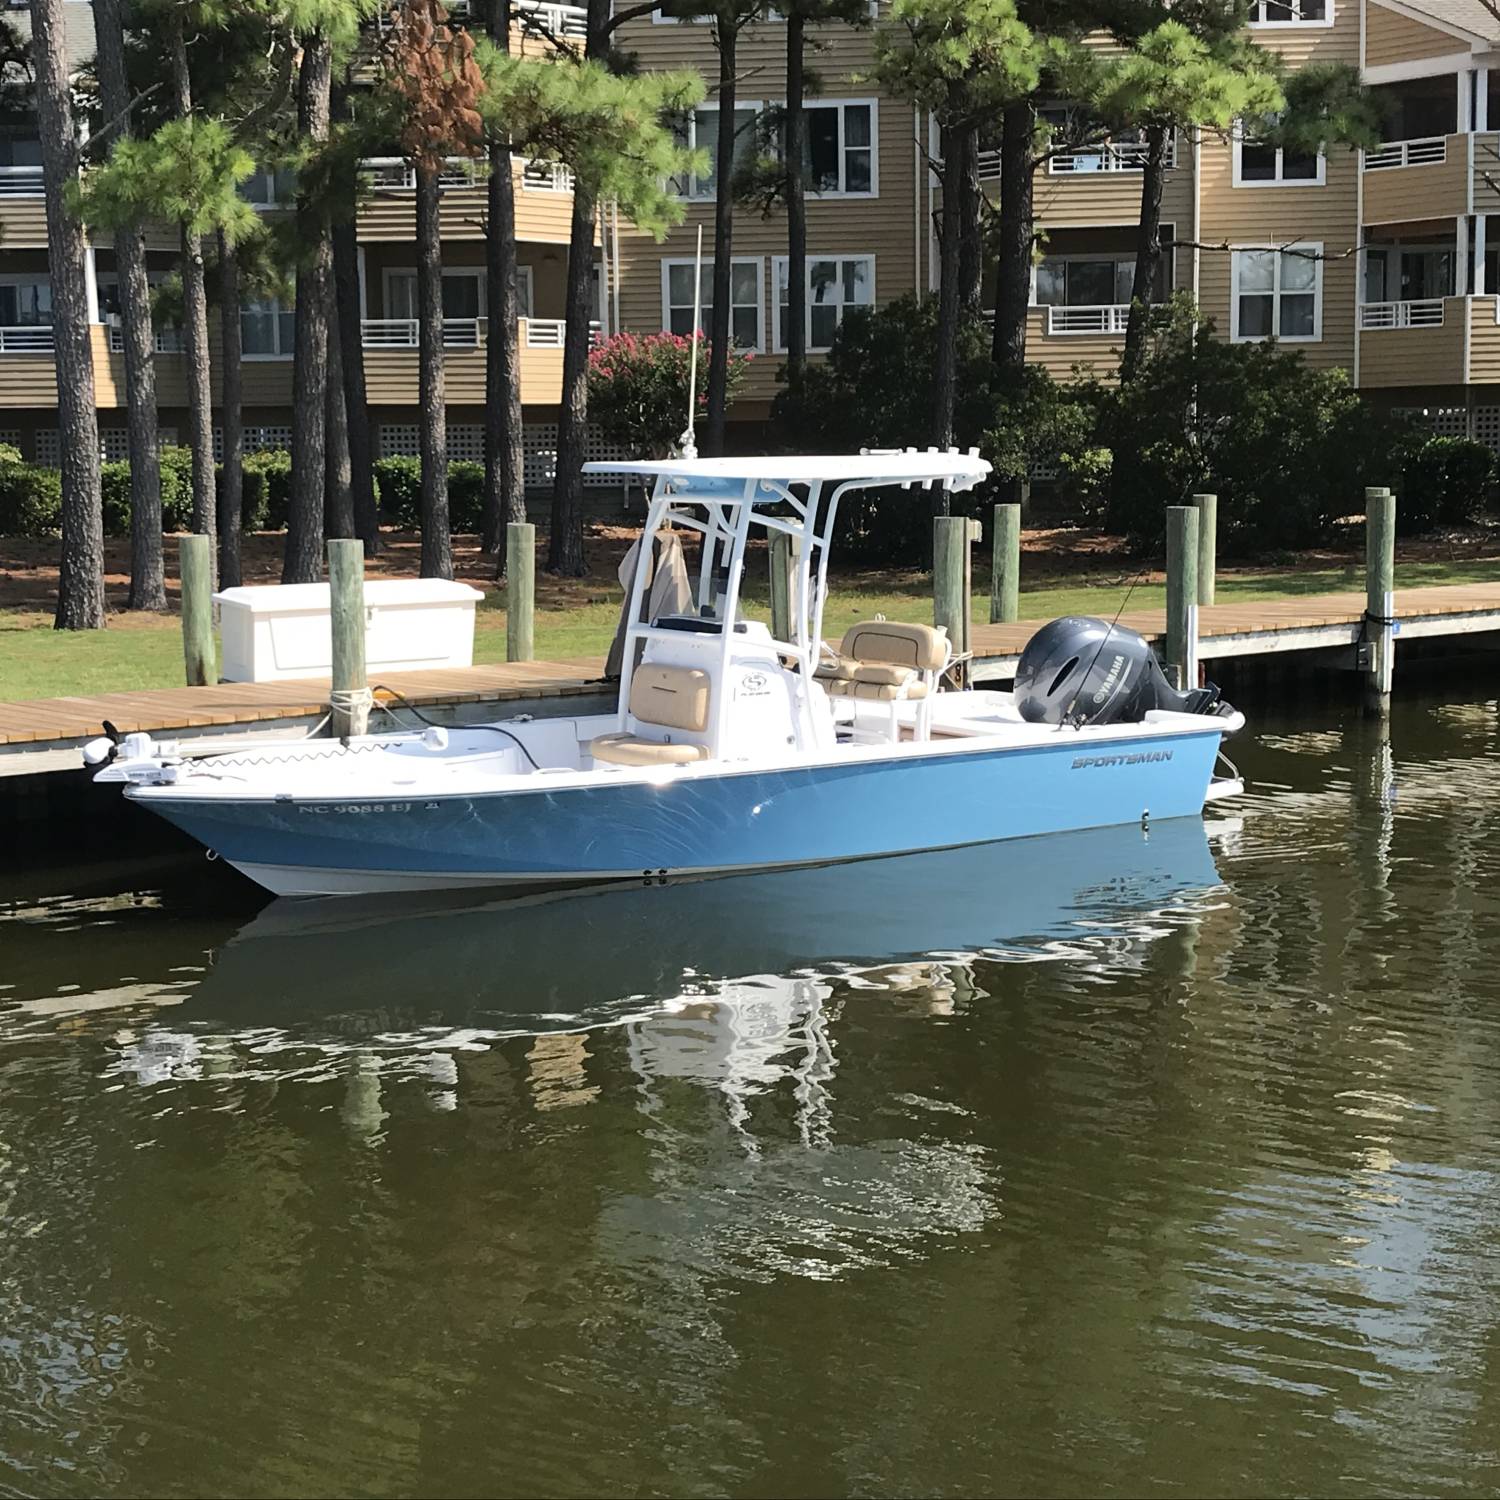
[282,35,333,584]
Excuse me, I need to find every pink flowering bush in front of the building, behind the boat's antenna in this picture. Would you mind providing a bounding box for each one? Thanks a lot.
[588,333,752,459]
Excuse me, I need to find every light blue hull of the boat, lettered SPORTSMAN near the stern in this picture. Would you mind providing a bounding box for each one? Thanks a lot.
[129,722,1221,896]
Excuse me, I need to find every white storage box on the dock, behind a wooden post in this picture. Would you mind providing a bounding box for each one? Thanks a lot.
[213,578,485,683]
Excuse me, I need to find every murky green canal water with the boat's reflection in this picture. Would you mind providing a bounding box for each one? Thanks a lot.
[0,702,1500,1496]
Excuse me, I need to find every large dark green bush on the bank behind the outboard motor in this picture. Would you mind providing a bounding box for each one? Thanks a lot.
[1100,299,1407,555]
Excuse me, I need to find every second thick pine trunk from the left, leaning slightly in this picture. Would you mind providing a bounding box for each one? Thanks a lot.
[93,0,167,611]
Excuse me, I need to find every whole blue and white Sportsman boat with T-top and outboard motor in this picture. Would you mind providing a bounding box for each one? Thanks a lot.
[87,453,1244,896]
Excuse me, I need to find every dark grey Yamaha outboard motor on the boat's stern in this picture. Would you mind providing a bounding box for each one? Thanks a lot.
[1016,615,1233,728]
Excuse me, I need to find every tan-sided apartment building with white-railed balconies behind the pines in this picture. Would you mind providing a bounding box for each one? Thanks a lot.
[0,0,1500,468]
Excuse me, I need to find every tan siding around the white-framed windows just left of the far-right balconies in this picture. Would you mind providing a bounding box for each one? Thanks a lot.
[1199,135,1359,368]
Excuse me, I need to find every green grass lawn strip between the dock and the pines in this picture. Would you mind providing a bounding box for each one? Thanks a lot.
[0,560,1500,701]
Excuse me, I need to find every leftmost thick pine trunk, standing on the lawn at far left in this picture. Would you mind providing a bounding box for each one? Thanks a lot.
[32,0,104,630]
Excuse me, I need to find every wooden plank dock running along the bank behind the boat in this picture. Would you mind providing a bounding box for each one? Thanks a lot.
[0,582,1500,776]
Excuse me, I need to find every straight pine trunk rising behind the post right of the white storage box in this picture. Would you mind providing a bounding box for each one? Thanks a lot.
[483,0,527,558]
